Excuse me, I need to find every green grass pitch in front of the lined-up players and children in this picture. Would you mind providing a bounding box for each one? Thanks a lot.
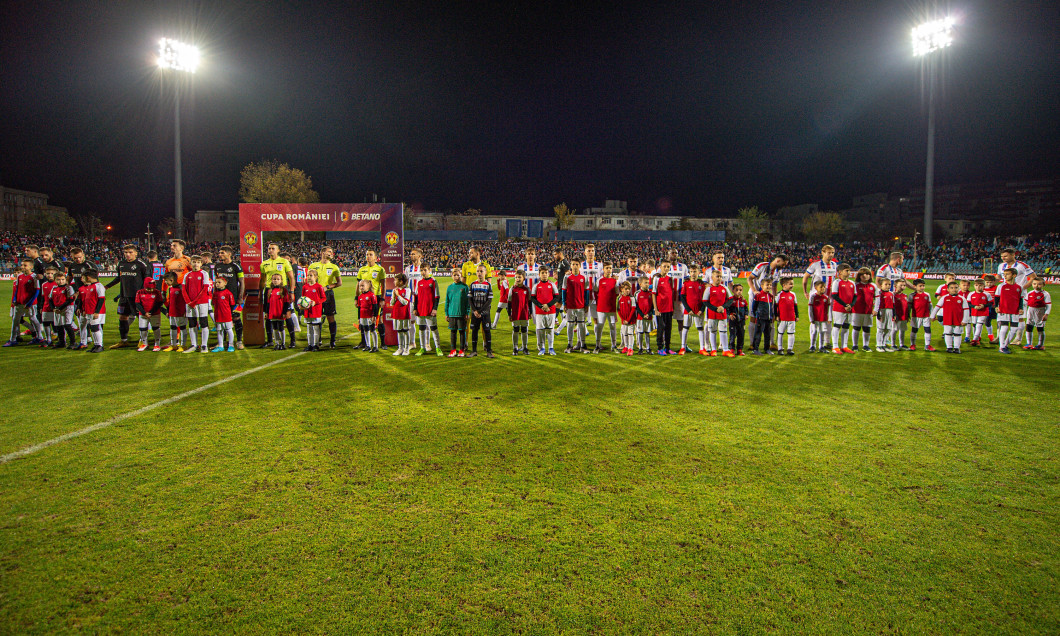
[0,277,1060,634]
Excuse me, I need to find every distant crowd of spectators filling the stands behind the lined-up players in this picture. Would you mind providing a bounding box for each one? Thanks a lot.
[0,232,1060,272]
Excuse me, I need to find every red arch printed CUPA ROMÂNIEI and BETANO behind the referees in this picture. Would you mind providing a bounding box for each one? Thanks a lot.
[240,204,405,345]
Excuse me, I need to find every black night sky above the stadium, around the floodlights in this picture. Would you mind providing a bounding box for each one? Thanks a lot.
[0,0,1060,230]
